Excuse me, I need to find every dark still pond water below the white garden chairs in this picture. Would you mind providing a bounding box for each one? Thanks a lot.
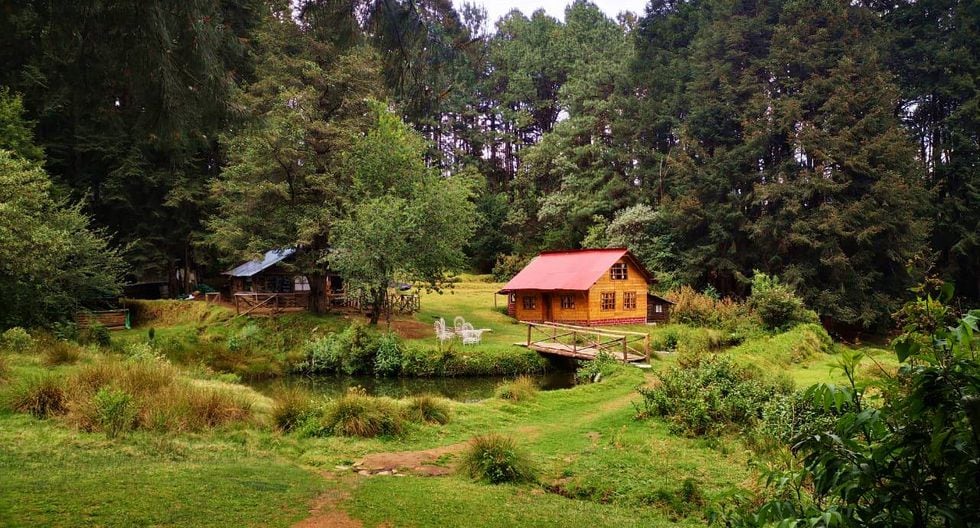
[253,371,575,402]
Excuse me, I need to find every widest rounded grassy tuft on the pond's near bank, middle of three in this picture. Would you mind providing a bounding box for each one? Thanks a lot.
[322,389,405,438]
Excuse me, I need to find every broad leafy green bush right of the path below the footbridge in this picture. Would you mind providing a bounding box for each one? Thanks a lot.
[638,357,789,436]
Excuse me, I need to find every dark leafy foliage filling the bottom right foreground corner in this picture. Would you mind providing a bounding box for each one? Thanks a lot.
[727,296,980,526]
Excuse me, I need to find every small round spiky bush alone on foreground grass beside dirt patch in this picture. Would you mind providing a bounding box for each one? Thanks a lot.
[459,433,535,484]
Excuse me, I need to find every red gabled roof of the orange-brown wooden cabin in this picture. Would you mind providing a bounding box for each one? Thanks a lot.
[500,248,654,293]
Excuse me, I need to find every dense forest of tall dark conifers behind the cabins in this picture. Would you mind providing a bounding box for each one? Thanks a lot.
[0,0,980,329]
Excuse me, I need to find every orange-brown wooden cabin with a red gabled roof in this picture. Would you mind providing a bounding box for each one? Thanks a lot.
[498,248,656,326]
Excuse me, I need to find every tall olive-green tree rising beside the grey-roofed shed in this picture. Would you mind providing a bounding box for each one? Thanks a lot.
[208,3,381,310]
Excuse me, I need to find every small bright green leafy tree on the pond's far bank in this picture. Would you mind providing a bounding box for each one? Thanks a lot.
[328,104,476,324]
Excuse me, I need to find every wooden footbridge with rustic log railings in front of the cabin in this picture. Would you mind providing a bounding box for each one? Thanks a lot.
[516,321,650,363]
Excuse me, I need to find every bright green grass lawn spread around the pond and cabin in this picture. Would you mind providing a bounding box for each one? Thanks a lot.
[0,278,895,527]
